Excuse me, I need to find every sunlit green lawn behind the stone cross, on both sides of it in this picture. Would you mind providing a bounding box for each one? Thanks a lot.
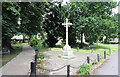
[36,43,118,55]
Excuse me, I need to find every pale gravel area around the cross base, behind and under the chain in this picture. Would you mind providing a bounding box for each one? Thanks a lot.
[37,51,97,75]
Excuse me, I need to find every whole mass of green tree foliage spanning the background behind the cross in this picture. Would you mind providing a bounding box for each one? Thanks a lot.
[2,2,118,49]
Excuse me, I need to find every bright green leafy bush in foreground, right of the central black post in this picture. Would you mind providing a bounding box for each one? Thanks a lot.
[79,63,92,75]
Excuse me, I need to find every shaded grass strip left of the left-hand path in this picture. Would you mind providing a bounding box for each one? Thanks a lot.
[0,44,23,67]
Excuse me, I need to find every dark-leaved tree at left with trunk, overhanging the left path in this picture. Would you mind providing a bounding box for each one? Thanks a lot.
[2,2,44,50]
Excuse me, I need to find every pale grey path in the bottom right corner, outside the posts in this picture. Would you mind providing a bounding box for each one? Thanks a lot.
[94,52,118,75]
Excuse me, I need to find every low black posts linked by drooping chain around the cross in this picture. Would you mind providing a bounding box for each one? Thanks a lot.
[29,49,111,77]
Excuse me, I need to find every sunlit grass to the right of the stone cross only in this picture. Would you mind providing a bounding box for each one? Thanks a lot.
[72,43,118,55]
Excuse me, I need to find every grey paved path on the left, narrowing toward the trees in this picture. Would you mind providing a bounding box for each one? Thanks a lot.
[0,45,35,75]
